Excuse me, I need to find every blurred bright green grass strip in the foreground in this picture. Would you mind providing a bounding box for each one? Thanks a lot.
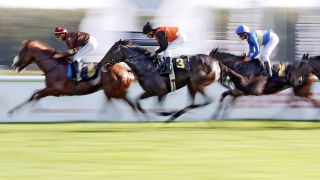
[0,121,320,180]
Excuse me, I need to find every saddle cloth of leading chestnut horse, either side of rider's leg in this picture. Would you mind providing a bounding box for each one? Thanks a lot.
[68,62,100,82]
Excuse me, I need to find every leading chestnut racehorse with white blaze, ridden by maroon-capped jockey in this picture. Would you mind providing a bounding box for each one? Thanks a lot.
[8,40,136,114]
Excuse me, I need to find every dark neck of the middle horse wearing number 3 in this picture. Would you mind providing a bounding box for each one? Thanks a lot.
[121,47,157,76]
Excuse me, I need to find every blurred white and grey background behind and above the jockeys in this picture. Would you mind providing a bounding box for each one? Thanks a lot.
[0,0,320,69]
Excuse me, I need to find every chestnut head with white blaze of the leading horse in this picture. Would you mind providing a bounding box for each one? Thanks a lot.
[11,40,55,72]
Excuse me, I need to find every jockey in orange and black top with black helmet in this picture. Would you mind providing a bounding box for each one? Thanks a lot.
[142,22,187,75]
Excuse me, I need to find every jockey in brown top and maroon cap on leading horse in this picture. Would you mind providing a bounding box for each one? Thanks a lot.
[53,26,97,81]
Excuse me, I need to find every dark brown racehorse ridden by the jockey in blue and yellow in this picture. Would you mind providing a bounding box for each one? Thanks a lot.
[209,48,319,116]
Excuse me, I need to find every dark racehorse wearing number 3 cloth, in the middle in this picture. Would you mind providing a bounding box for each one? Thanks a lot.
[101,39,220,122]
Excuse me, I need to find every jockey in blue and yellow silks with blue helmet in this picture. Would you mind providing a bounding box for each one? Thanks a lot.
[236,25,279,77]
